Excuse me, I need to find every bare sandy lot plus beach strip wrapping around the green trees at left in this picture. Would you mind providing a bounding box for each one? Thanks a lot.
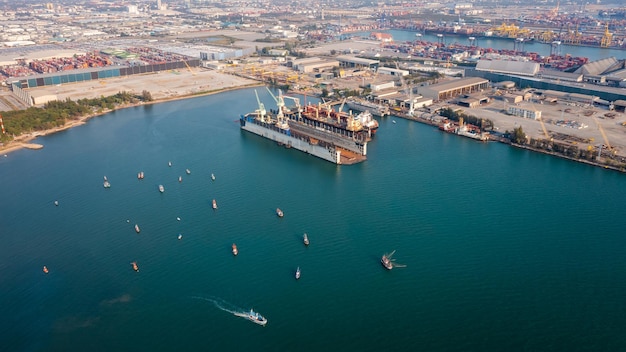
[0,70,262,155]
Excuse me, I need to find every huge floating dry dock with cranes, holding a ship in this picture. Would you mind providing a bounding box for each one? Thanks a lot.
[240,89,372,164]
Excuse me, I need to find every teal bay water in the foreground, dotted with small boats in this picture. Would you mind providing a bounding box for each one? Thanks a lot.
[0,89,626,351]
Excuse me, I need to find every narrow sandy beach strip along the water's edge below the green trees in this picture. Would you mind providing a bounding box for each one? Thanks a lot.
[0,82,264,156]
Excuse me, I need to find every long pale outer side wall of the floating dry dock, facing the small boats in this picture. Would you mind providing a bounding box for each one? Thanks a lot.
[240,117,342,164]
